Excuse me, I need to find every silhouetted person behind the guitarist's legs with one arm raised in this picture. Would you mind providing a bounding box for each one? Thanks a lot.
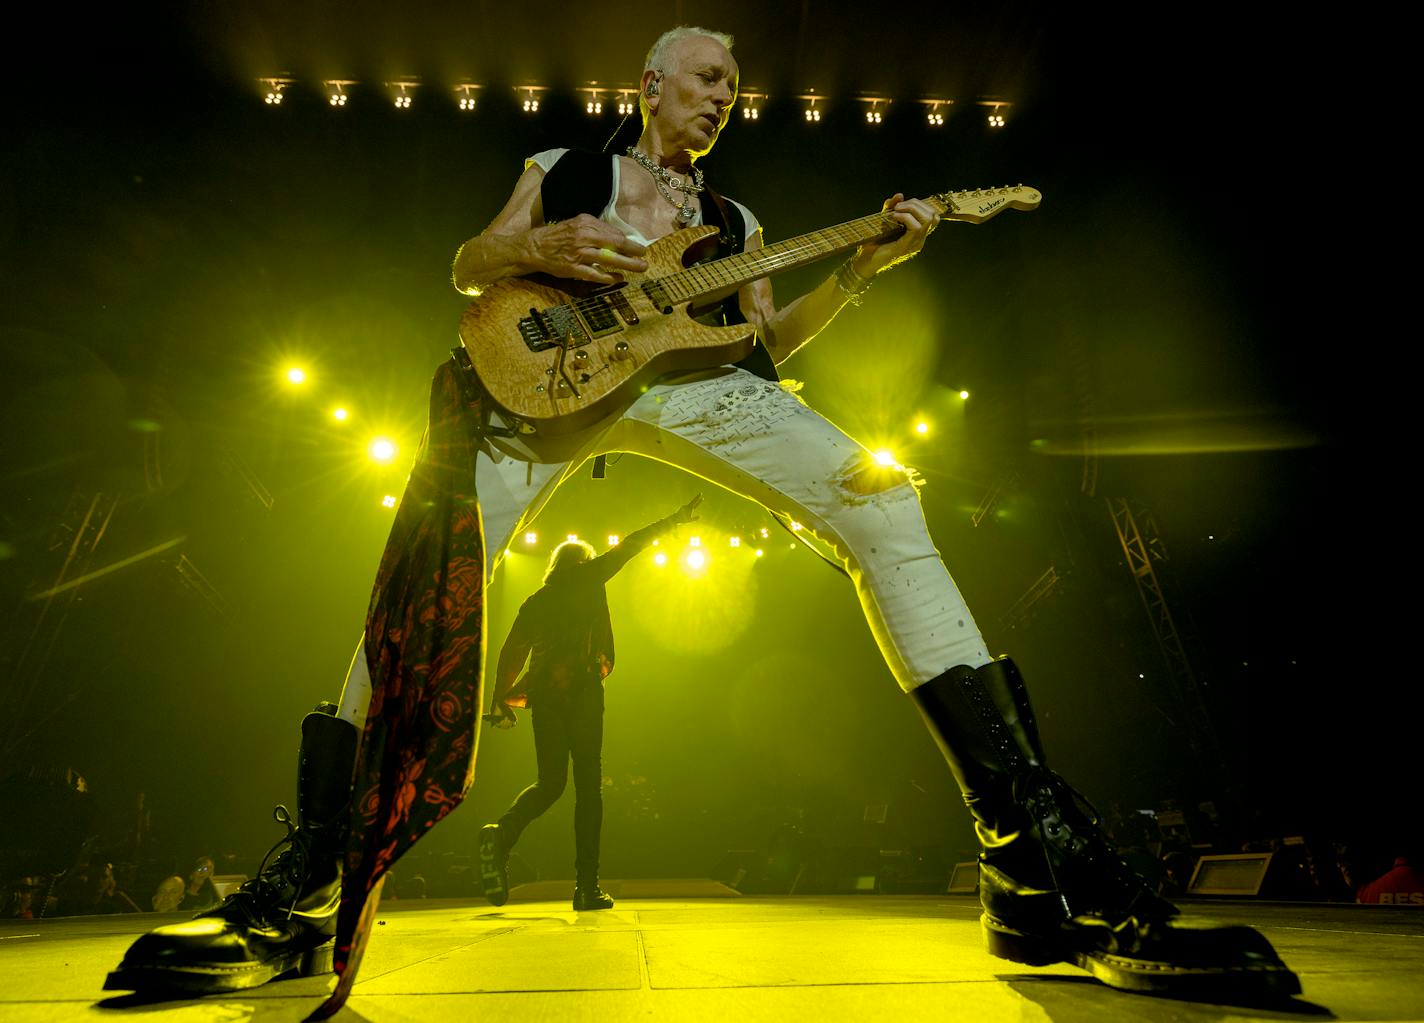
[480,494,702,910]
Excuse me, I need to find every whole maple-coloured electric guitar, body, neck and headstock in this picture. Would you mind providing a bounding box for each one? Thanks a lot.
[460,185,1042,439]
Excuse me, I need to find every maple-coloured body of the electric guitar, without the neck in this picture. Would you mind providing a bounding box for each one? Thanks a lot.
[460,227,756,437]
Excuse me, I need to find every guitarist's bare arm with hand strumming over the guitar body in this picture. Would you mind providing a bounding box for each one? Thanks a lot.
[453,165,648,295]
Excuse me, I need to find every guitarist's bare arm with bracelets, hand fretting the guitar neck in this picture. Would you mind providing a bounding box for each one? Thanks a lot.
[738,194,940,362]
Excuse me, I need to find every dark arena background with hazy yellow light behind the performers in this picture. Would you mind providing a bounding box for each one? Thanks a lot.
[0,3,1401,900]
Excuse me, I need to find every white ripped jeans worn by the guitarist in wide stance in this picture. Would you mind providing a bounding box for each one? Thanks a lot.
[340,368,991,724]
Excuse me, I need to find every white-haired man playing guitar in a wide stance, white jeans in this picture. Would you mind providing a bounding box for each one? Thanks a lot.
[107,26,1299,1004]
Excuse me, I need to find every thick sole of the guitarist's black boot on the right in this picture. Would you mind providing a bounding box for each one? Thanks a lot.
[981,913,1300,1002]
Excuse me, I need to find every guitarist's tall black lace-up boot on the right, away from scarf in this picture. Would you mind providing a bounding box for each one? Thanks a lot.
[911,658,1300,1000]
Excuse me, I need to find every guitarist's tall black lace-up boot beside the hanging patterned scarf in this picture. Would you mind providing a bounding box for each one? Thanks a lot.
[104,704,360,995]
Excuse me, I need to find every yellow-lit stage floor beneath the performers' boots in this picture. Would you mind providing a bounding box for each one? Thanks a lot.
[0,882,1424,1023]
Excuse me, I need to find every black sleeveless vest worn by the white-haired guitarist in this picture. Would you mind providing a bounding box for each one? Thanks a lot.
[540,150,780,380]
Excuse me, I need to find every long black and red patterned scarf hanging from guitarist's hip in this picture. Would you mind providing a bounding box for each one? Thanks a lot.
[309,359,484,1019]
